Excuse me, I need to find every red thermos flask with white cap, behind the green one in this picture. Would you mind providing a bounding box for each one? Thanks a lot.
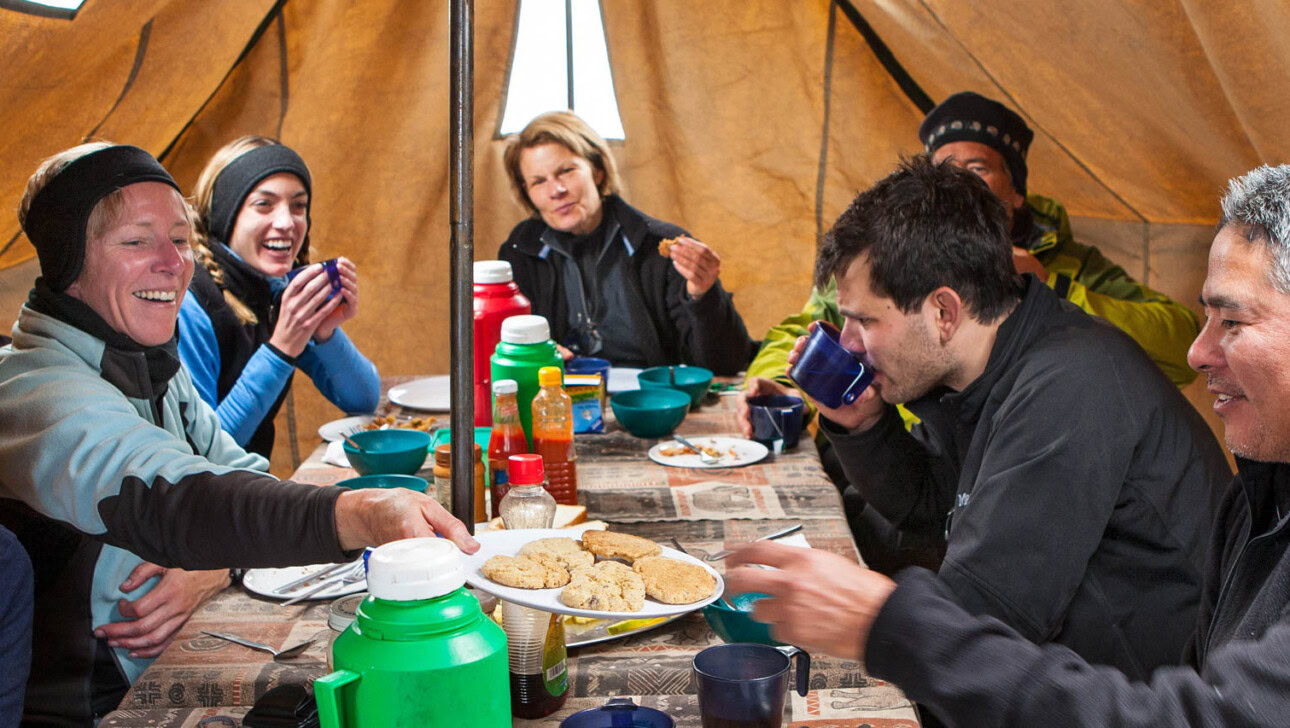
[475,261,533,427]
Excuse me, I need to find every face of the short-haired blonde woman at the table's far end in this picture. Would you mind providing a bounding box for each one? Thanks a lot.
[520,142,604,235]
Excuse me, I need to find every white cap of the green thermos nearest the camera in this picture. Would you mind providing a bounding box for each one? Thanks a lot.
[368,537,466,602]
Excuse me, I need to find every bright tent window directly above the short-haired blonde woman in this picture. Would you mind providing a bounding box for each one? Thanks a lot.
[501,0,624,139]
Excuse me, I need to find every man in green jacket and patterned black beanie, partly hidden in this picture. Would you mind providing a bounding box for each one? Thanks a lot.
[738,92,1200,571]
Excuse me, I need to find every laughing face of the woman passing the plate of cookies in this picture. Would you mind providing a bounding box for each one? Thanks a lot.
[67,182,192,346]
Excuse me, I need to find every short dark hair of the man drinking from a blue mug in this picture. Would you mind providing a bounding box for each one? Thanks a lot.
[815,155,1023,323]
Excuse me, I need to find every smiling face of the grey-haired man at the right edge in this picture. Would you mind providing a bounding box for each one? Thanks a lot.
[1187,225,1290,462]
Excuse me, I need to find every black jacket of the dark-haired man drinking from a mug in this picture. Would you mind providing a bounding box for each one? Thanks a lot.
[826,276,1231,679]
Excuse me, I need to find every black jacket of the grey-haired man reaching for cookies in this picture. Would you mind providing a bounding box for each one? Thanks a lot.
[866,460,1290,728]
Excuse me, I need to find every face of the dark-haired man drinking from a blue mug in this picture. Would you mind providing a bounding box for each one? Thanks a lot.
[837,254,955,404]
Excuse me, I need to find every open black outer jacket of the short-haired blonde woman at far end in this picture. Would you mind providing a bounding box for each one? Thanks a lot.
[498,195,756,374]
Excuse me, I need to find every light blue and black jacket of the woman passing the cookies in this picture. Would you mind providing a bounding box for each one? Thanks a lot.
[0,306,344,725]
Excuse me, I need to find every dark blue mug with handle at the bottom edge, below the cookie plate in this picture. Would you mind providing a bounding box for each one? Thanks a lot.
[693,643,810,728]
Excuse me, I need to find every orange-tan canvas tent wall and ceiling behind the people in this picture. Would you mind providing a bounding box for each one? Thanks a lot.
[0,0,1290,474]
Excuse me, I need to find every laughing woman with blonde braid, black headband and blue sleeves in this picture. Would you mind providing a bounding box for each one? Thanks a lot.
[179,137,381,457]
